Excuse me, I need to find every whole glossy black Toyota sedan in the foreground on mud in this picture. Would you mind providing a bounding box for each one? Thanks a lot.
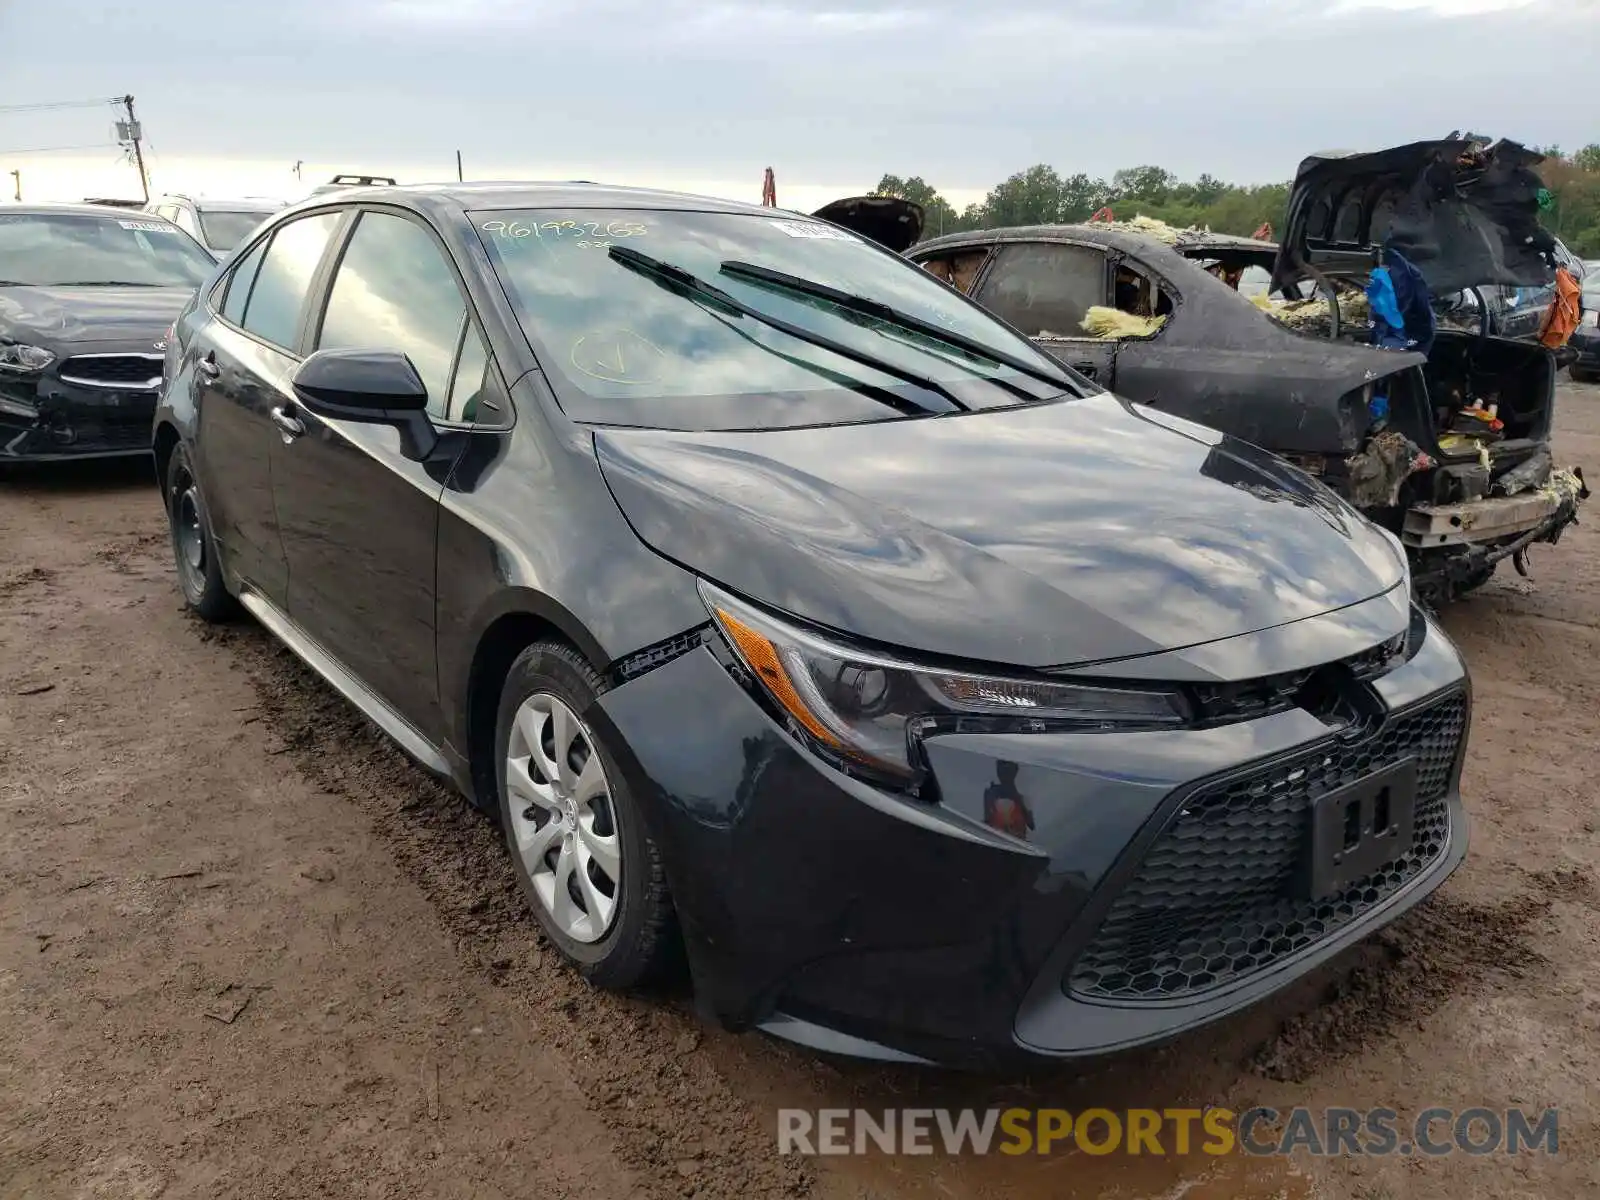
[155,184,1469,1062]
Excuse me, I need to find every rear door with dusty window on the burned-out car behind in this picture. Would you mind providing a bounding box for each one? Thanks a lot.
[973,242,1117,387]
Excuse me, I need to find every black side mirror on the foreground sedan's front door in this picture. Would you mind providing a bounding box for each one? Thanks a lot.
[290,350,438,462]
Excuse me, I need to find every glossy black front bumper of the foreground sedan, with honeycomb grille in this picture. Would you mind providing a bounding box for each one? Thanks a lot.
[590,614,1470,1066]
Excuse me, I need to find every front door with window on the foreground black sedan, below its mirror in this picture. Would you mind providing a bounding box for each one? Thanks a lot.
[272,208,476,738]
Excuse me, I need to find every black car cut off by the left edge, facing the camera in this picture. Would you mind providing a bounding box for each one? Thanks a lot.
[0,205,216,462]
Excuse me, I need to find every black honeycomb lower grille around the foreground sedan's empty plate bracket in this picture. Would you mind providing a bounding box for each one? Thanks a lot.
[1064,691,1467,1002]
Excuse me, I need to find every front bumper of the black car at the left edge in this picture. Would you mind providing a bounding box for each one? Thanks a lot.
[0,363,160,462]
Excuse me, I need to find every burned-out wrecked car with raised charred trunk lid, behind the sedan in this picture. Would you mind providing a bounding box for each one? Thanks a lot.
[889,138,1589,605]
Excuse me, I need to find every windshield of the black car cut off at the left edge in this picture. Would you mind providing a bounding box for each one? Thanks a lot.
[0,213,216,288]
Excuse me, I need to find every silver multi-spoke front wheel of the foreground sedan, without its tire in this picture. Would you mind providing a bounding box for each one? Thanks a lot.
[504,691,622,942]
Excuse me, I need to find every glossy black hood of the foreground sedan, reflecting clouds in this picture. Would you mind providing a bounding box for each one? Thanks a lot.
[595,394,1405,667]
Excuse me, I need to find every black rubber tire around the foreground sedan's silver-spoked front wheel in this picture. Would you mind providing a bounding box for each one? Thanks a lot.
[493,642,675,990]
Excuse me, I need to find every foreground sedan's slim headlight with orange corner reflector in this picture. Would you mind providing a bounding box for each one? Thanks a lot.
[701,582,1187,784]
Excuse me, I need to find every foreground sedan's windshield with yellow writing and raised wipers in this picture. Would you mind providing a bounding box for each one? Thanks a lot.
[472,210,1066,429]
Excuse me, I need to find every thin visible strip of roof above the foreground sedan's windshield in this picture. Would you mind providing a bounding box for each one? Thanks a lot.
[278,181,796,221]
